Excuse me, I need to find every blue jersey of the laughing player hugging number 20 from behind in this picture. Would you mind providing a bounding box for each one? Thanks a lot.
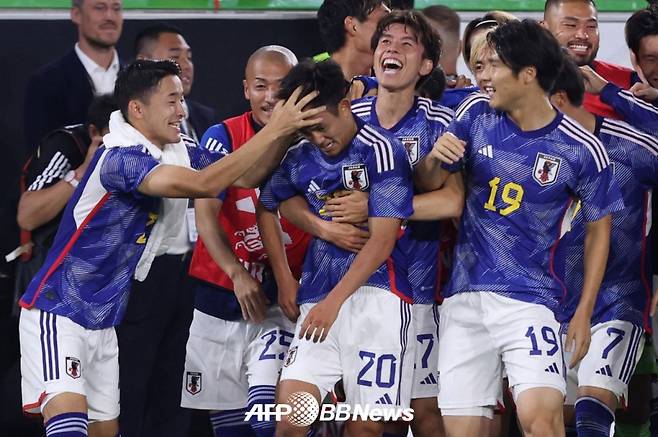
[352,97,454,304]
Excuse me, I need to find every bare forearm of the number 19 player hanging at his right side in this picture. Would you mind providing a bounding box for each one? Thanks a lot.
[578,215,611,316]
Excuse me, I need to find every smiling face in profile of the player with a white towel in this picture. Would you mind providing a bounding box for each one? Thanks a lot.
[134,76,185,148]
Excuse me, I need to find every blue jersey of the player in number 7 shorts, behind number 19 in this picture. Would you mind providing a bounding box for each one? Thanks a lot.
[558,117,658,330]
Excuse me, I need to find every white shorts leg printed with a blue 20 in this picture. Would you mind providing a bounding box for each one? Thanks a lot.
[339,287,415,408]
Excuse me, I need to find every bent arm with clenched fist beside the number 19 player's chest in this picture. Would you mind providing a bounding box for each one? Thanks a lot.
[414,132,466,192]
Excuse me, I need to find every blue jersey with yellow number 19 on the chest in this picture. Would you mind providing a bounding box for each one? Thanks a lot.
[444,95,623,311]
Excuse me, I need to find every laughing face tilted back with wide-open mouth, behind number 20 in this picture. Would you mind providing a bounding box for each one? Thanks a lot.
[374,23,434,90]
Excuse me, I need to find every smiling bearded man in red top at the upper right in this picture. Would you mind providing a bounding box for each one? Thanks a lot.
[542,0,639,118]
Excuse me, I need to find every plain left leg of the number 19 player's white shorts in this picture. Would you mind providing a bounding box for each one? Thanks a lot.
[439,292,502,408]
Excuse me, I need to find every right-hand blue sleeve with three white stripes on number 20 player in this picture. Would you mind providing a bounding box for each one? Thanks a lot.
[368,137,413,220]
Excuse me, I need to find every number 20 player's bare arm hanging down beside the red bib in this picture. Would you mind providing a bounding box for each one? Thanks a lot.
[256,202,299,322]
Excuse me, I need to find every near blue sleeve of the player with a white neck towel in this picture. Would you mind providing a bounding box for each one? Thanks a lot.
[100,146,160,197]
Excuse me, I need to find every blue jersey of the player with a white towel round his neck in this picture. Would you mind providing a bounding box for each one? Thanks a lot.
[20,140,218,329]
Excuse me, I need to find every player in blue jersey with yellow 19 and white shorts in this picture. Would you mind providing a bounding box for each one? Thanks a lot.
[420,20,622,436]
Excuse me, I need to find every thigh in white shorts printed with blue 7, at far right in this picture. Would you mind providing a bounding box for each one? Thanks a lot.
[565,320,645,410]
